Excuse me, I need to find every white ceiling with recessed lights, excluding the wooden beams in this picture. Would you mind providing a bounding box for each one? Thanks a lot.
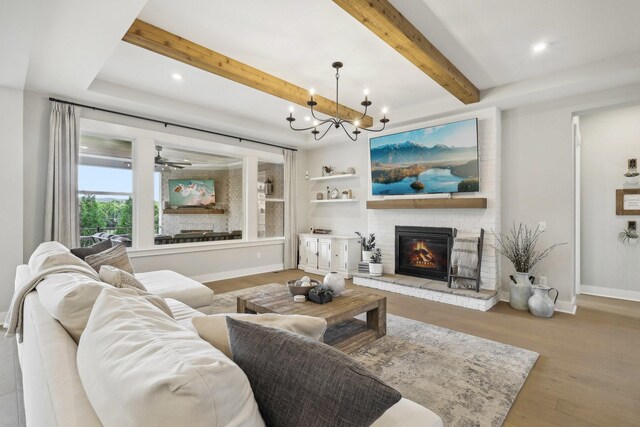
[7,0,640,147]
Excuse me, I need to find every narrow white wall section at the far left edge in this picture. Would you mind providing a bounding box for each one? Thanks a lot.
[0,87,23,311]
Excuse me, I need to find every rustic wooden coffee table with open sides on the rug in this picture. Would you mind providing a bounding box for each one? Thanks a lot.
[238,286,387,353]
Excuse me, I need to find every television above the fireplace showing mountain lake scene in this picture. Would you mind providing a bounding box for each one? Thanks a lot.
[369,119,480,196]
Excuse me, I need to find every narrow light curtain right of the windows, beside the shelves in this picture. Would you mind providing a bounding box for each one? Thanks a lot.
[284,150,298,269]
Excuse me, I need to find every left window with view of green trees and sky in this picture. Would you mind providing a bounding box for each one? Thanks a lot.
[78,134,133,246]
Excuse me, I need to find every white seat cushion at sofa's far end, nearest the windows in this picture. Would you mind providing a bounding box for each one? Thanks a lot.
[136,270,214,308]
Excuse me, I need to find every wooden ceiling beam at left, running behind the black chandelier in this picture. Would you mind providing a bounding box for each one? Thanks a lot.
[122,19,373,128]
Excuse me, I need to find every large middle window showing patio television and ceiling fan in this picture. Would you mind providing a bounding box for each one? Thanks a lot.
[154,146,244,245]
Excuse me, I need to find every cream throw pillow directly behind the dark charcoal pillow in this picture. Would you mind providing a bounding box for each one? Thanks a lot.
[191,313,327,357]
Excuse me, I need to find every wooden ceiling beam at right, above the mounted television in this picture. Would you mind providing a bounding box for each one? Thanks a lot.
[333,0,480,104]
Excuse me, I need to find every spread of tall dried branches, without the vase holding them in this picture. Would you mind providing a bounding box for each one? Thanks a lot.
[493,223,566,273]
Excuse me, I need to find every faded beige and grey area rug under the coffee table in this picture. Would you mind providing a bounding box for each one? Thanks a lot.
[213,284,538,427]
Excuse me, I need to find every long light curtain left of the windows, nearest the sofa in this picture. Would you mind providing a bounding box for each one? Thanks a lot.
[44,101,80,247]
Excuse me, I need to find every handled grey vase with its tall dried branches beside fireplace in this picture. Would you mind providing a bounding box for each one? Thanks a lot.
[494,223,565,310]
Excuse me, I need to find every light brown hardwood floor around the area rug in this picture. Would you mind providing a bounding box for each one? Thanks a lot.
[207,270,640,427]
